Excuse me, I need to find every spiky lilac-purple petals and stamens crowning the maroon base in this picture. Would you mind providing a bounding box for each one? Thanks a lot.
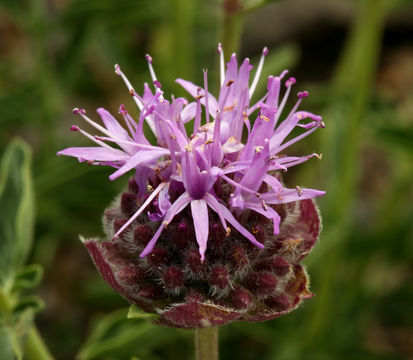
[58,46,324,262]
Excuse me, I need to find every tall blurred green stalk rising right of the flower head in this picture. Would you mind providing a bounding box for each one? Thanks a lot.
[307,0,389,343]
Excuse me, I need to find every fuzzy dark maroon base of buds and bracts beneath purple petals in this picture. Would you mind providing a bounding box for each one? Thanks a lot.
[83,174,320,329]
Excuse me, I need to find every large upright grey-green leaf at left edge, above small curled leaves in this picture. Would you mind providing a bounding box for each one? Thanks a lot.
[0,139,34,286]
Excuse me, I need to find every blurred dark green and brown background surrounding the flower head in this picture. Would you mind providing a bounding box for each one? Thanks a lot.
[0,0,413,360]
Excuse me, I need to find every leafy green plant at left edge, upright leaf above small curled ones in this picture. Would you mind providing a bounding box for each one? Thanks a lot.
[0,140,48,360]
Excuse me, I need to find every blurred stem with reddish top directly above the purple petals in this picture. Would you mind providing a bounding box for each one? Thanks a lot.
[221,0,244,59]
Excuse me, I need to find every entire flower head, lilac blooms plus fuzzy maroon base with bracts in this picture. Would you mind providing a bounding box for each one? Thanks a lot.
[58,46,324,327]
